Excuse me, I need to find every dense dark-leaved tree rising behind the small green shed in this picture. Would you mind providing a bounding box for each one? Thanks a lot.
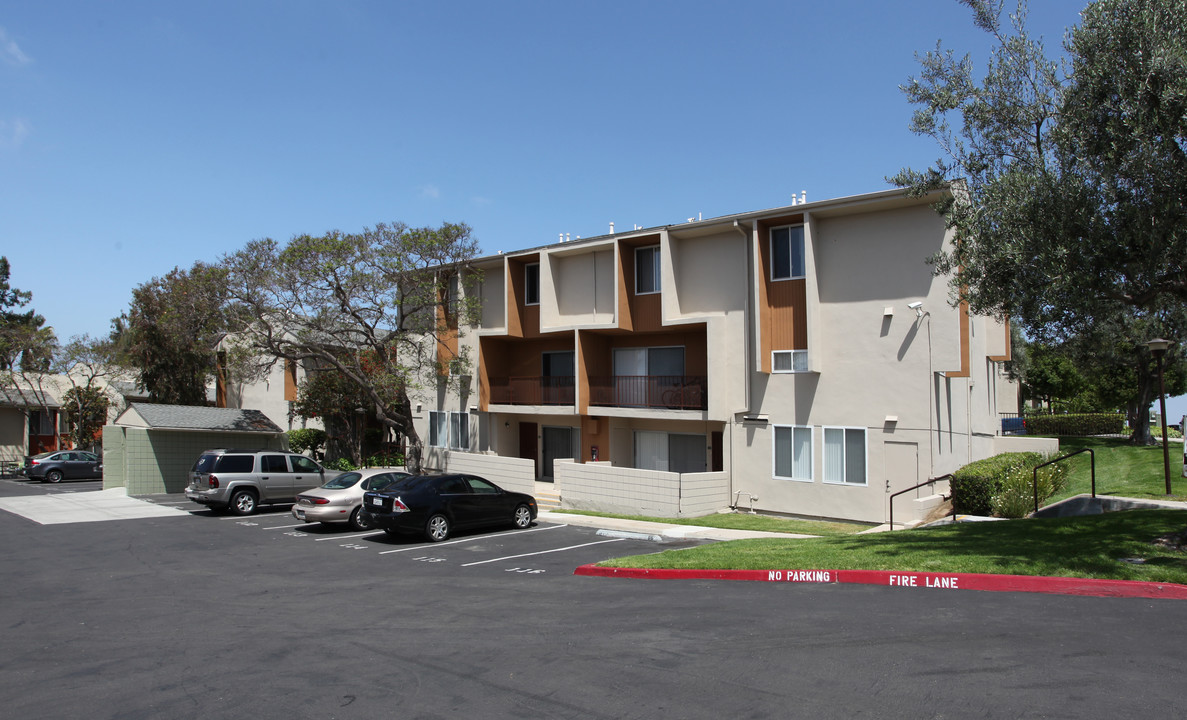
[112,262,250,406]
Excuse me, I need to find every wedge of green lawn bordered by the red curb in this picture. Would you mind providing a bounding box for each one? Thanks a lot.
[601,510,1187,584]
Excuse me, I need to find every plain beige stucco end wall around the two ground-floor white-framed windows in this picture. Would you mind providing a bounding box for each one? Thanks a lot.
[728,206,1013,522]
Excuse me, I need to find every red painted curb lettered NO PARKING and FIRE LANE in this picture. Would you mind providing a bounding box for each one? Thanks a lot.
[573,565,1187,600]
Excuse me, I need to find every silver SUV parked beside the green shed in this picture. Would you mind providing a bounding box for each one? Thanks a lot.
[185,450,339,515]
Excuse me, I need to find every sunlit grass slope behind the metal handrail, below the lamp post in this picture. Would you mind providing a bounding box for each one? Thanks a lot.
[1048,438,1187,502]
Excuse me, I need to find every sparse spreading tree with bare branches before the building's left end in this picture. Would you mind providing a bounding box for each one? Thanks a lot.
[222,223,478,467]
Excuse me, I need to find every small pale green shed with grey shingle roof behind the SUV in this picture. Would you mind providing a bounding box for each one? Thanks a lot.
[103,402,288,495]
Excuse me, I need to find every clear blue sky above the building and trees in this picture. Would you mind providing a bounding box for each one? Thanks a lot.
[9,0,1172,416]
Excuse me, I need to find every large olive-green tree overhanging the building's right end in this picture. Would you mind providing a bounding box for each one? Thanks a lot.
[893,0,1187,441]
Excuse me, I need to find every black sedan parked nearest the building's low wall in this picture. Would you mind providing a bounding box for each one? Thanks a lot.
[363,474,537,542]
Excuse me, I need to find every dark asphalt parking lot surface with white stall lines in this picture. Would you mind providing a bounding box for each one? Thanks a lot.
[0,480,1187,720]
